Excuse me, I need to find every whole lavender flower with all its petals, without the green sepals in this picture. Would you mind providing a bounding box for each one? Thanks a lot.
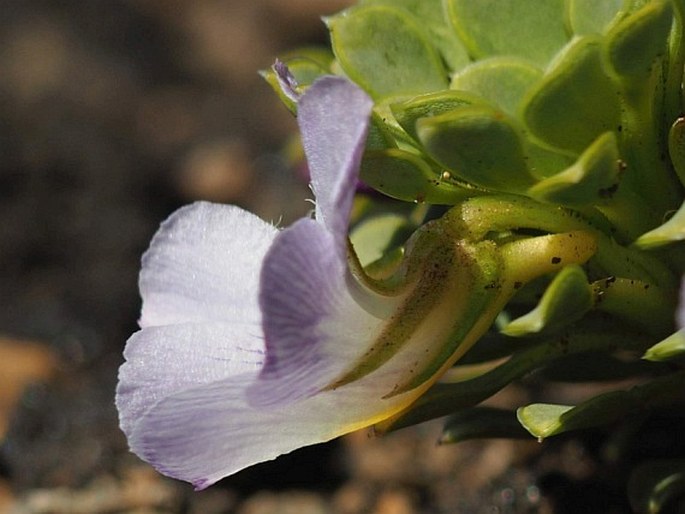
[116,77,454,489]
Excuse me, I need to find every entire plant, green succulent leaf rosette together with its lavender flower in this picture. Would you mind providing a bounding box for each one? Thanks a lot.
[117,0,685,508]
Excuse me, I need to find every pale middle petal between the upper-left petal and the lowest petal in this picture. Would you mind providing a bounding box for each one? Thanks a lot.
[116,323,264,435]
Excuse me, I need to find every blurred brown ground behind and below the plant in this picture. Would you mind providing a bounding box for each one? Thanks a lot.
[0,0,632,514]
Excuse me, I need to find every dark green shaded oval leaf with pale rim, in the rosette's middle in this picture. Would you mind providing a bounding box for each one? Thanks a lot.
[416,105,534,192]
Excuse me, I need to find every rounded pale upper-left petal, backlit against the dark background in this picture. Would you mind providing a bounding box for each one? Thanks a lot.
[140,202,278,327]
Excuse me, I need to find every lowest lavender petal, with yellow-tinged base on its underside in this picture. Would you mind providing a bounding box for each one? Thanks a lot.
[129,354,420,490]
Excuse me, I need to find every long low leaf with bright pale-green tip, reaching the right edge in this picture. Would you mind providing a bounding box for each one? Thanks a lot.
[516,372,685,440]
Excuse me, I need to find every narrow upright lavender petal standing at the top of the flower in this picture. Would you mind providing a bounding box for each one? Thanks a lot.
[297,76,373,247]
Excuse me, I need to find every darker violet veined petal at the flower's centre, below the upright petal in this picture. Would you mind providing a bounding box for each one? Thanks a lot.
[250,219,381,406]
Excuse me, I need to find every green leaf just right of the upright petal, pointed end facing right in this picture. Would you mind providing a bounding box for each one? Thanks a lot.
[361,148,483,205]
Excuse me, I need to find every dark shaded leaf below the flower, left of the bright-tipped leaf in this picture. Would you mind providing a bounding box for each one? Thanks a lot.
[439,407,530,444]
